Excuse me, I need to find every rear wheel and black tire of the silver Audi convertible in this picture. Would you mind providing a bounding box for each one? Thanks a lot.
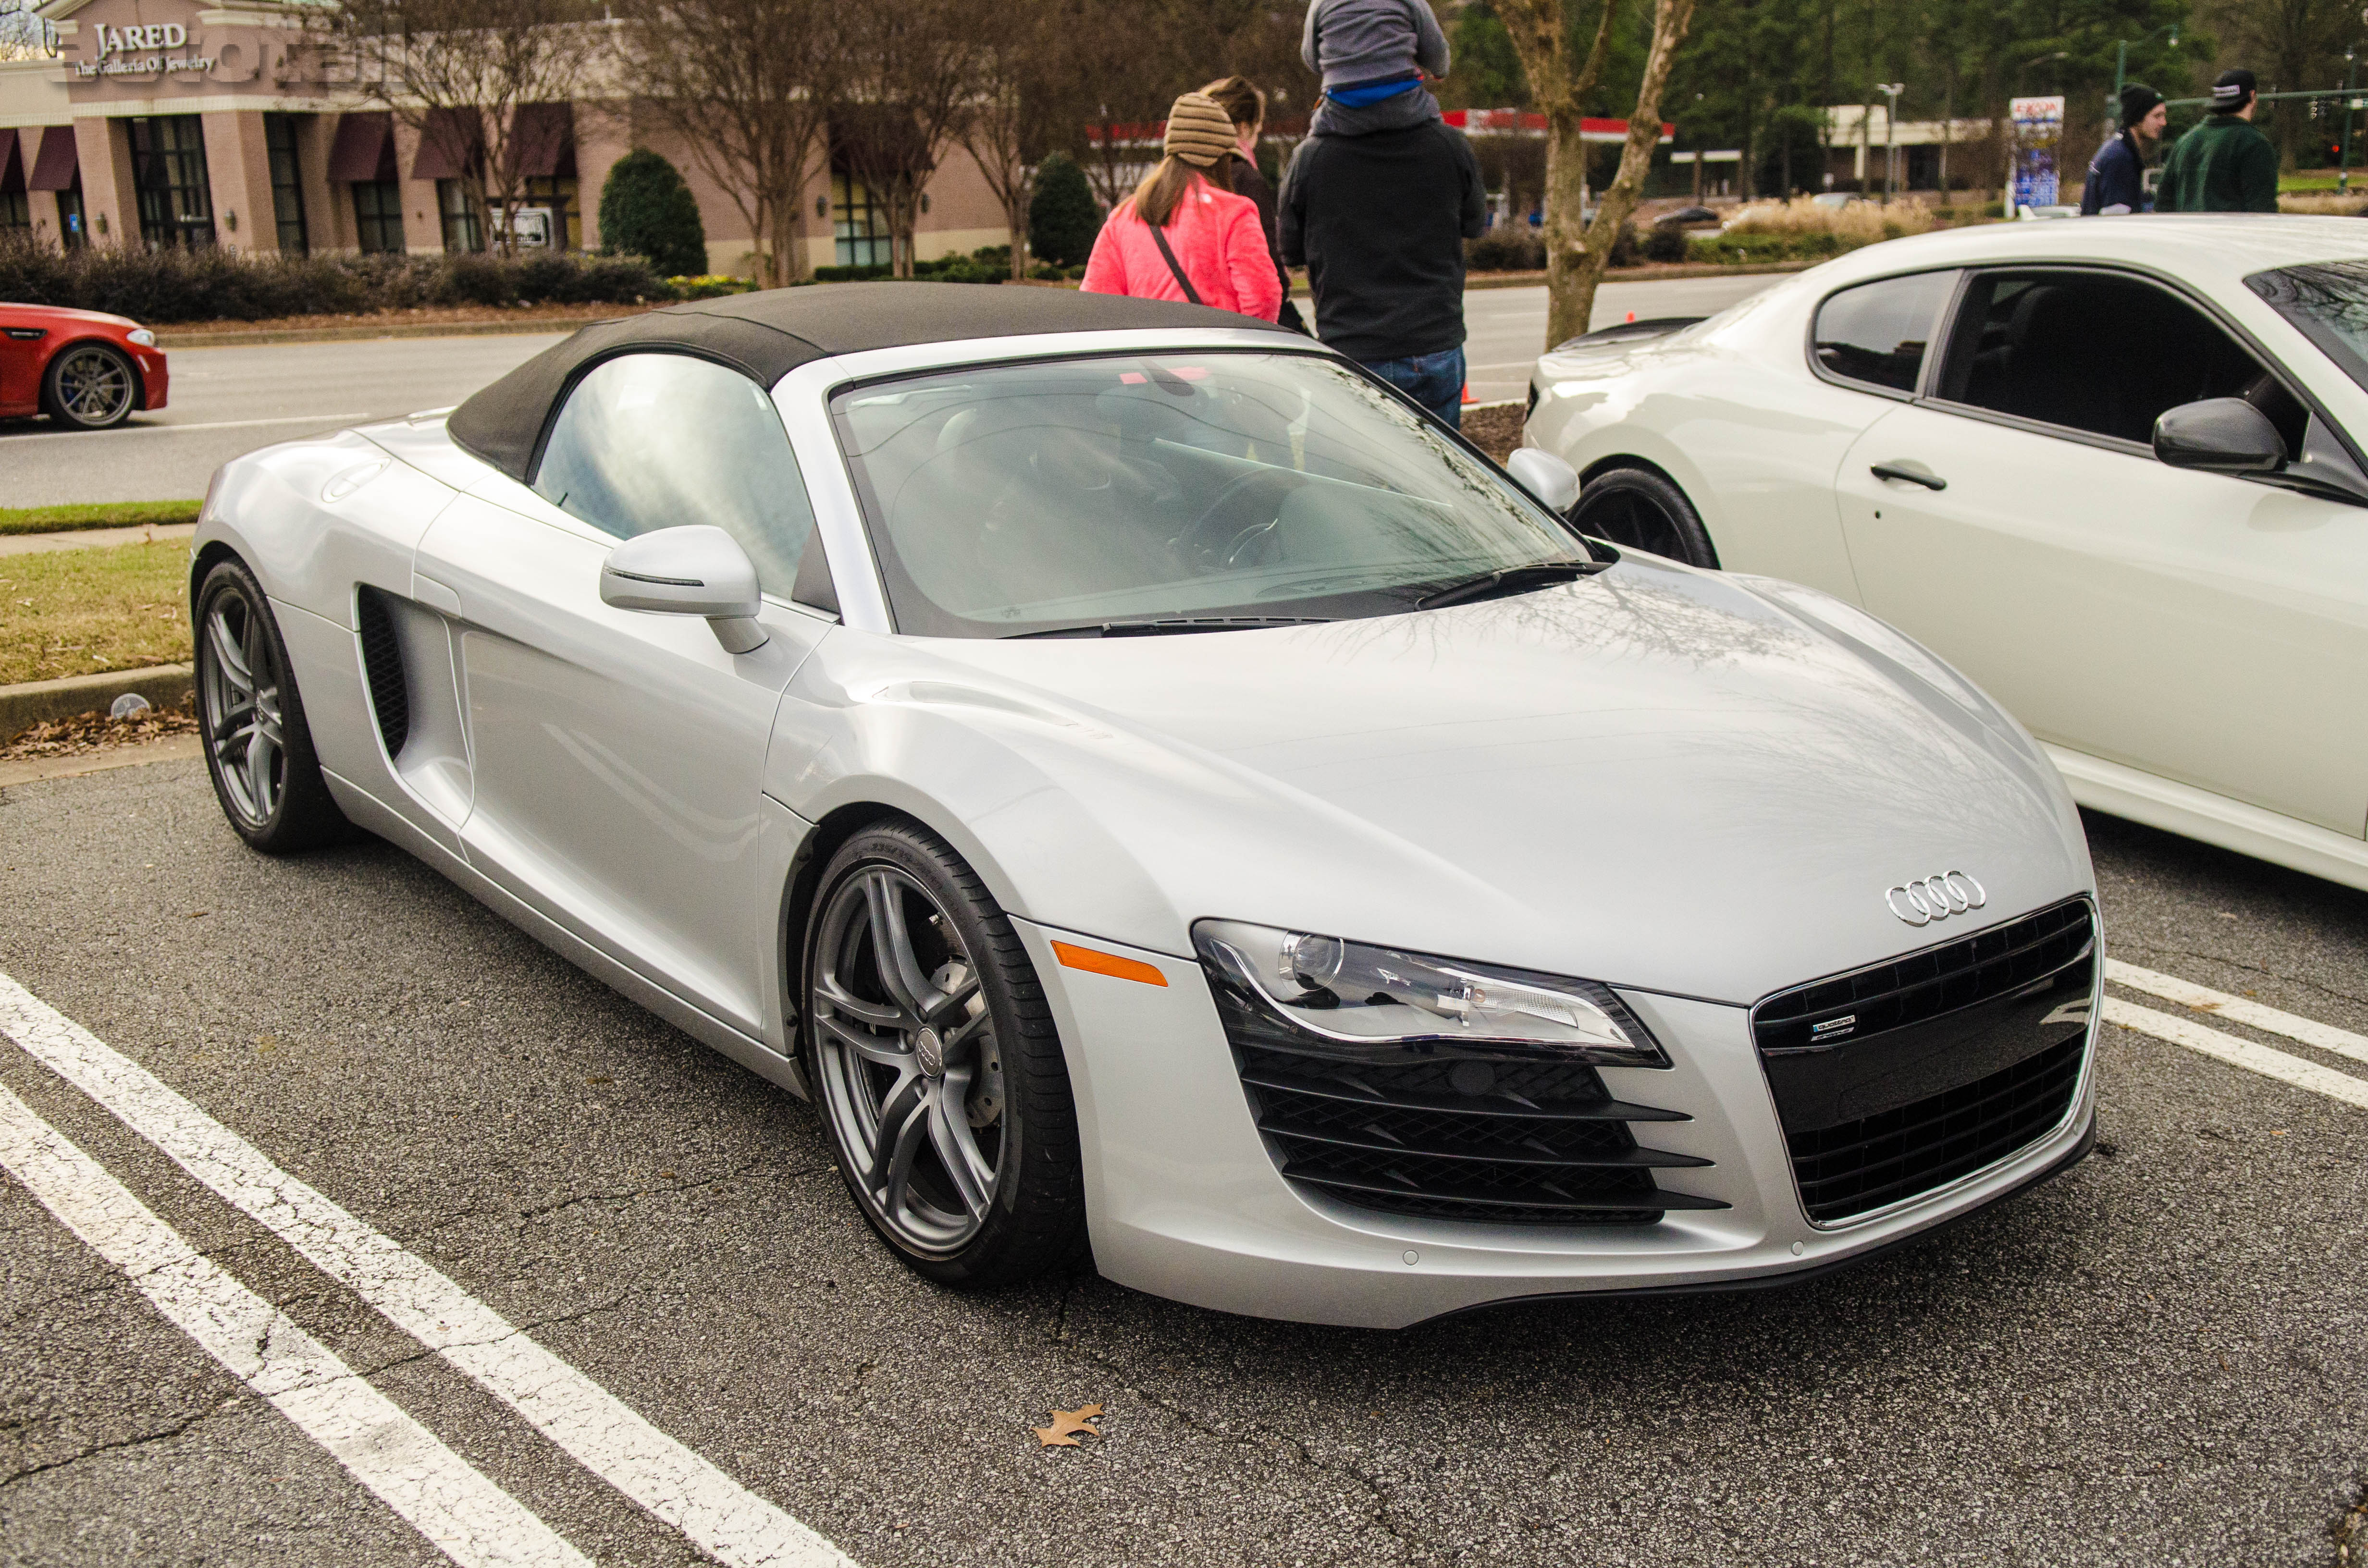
[192,562,355,855]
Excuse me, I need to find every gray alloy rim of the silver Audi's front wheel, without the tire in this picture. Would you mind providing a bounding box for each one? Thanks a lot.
[812,865,1004,1258]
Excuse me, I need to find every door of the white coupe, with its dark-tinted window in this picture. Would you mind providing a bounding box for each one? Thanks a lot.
[1838,268,2368,836]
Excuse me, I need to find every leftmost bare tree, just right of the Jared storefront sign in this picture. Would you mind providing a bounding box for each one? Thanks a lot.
[294,0,608,254]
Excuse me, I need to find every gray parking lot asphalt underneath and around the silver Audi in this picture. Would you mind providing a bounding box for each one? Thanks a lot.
[0,763,2368,1568]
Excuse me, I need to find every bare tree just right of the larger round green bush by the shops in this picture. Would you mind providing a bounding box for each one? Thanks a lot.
[618,0,845,289]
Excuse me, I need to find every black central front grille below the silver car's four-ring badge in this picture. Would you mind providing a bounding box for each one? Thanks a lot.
[1752,900,2098,1220]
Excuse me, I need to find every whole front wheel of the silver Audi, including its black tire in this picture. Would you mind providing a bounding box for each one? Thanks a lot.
[798,822,1087,1286]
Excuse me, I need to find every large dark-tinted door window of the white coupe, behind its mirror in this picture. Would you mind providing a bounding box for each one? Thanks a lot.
[1937,270,2309,457]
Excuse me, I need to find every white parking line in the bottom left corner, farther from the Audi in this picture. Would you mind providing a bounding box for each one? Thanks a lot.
[0,1087,592,1568]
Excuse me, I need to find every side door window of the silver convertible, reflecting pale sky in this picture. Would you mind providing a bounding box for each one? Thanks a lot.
[535,353,831,609]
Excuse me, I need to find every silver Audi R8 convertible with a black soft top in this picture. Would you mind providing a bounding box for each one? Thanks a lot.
[189,284,2098,1326]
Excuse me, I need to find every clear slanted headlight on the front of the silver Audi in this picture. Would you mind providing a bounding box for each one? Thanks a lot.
[1191,919,1669,1066]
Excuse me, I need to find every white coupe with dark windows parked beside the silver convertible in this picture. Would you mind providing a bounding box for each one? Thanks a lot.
[1528,216,2368,888]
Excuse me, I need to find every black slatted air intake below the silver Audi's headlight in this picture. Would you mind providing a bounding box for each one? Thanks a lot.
[1220,1042,1727,1225]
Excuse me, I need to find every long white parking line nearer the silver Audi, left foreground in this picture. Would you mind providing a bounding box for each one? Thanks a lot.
[0,973,855,1568]
